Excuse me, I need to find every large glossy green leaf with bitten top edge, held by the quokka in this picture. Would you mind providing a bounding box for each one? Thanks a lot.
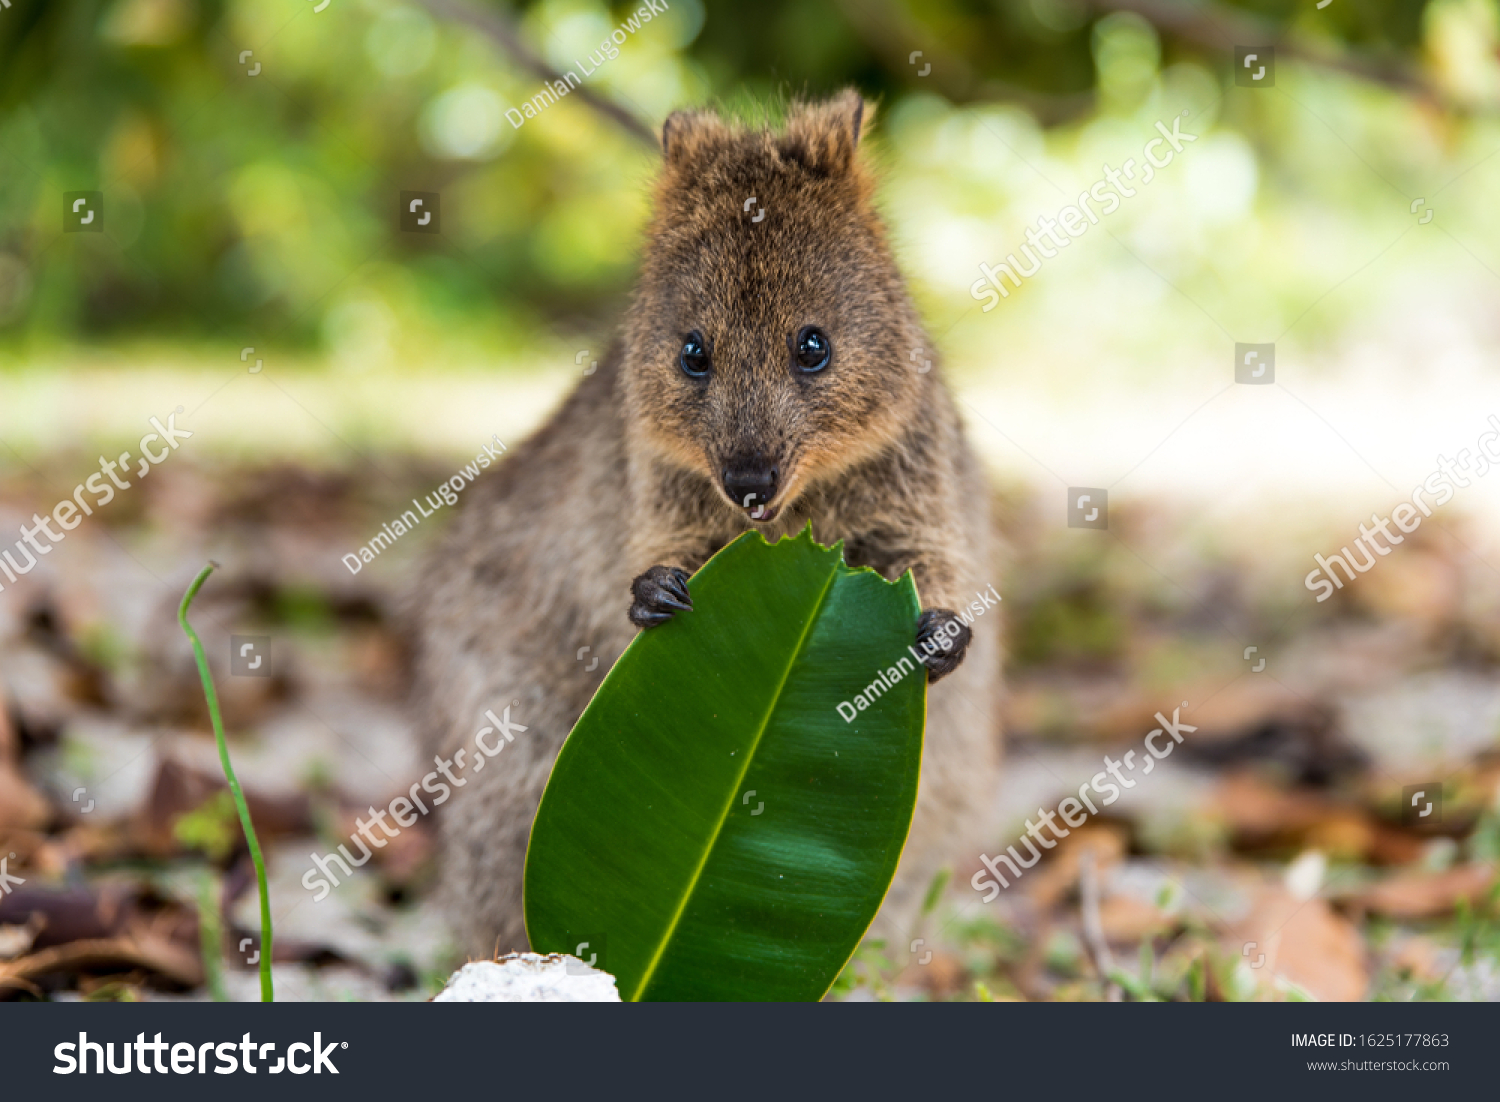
[525,529,927,1000]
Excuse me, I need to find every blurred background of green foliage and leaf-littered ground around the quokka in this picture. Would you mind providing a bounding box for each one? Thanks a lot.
[0,0,1500,999]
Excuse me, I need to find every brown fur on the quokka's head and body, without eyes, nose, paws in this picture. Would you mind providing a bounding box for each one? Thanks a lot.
[414,91,1001,954]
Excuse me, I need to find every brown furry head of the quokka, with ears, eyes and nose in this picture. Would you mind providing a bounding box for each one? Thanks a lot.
[623,91,932,523]
